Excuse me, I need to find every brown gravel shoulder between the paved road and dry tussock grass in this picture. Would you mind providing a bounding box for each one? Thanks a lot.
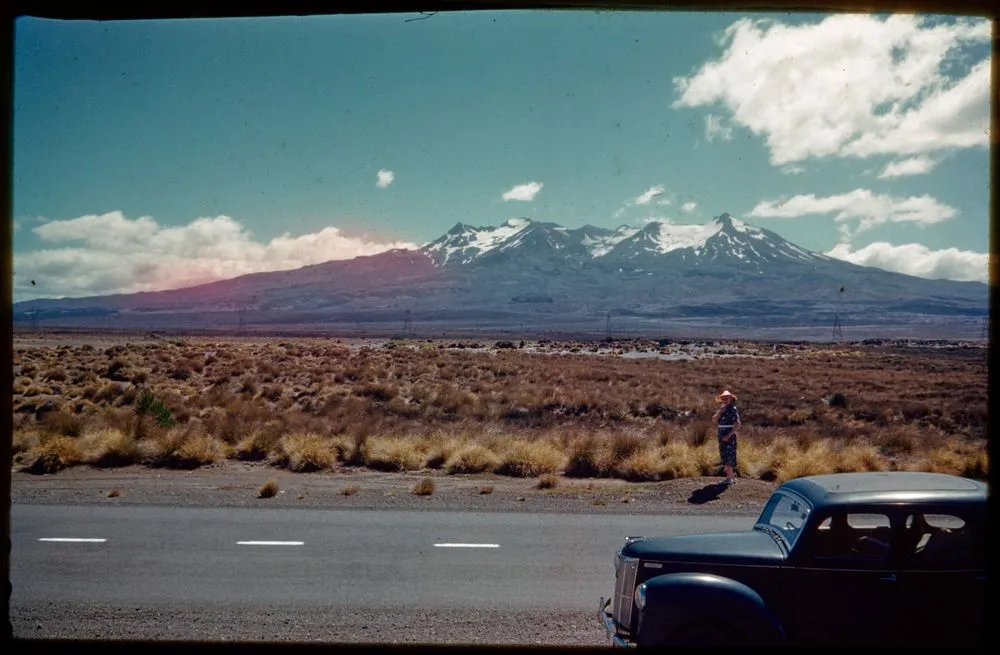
[11,462,775,515]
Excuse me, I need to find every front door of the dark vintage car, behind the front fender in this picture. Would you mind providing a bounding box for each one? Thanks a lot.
[785,509,900,646]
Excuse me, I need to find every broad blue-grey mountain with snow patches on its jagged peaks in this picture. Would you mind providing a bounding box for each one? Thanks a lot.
[13,214,988,338]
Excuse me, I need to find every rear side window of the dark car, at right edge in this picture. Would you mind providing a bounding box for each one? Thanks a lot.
[902,513,985,570]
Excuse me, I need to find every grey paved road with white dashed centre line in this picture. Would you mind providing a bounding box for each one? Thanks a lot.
[11,505,753,636]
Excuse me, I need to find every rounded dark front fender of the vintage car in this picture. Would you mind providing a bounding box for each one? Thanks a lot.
[636,573,785,646]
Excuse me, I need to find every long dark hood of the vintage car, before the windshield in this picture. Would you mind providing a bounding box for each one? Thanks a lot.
[622,530,785,564]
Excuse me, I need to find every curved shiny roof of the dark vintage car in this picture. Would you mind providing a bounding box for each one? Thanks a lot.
[780,471,987,509]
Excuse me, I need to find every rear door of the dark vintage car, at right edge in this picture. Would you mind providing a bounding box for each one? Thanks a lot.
[899,507,986,647]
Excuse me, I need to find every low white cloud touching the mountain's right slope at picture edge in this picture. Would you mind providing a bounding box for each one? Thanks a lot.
[826,241,989,282]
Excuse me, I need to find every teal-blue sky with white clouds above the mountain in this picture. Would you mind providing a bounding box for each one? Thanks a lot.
[13,11,990,301]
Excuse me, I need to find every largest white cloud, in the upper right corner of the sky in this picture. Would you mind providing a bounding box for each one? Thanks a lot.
[673,14,991,166]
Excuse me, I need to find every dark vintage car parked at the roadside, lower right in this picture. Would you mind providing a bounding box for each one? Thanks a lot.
[600,472,987,647]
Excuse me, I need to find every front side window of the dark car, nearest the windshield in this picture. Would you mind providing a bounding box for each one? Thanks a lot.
[812,512,892,565]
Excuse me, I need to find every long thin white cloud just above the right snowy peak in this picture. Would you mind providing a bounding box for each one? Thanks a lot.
[749,189,958,232]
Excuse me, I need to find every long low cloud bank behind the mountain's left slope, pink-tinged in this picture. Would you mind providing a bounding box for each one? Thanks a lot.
[14,211,418,300]
